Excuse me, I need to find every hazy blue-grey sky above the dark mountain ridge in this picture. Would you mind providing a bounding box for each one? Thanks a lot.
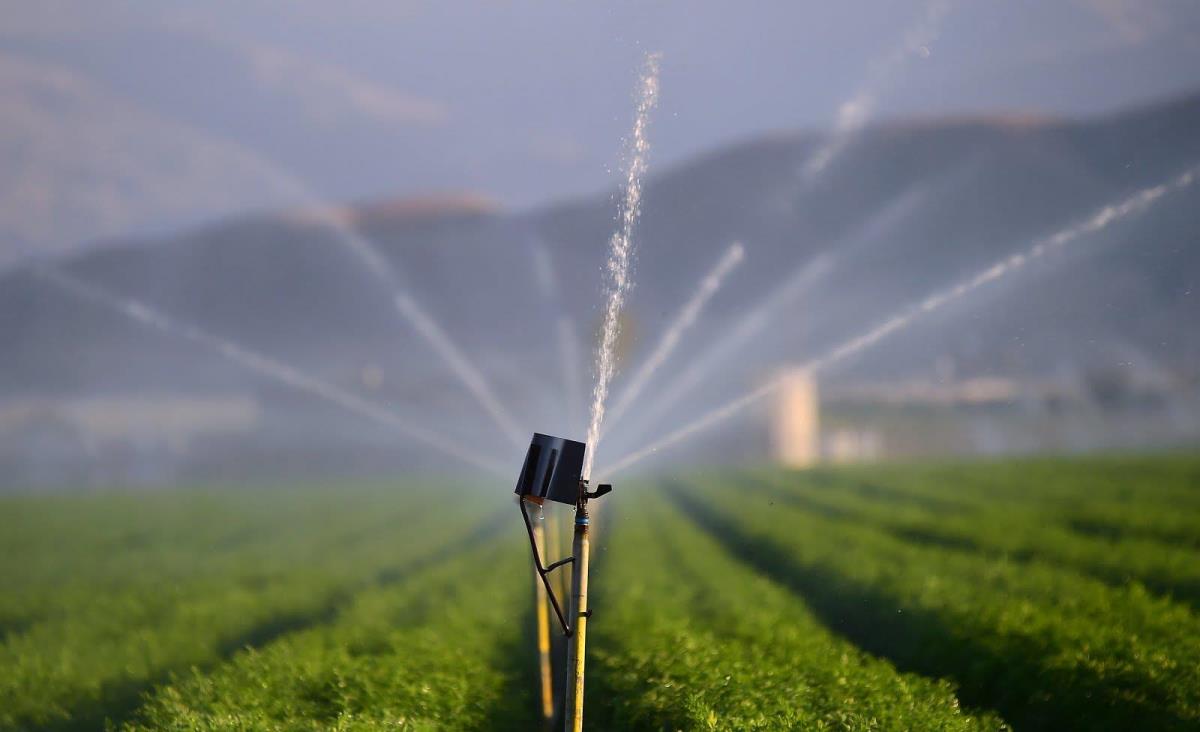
[0,0,1200,260]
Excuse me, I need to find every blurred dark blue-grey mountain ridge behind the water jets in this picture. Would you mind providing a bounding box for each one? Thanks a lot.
[0,90,1200,472]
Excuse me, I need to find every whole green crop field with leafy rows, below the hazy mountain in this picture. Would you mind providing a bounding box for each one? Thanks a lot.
[0,457,1200,731]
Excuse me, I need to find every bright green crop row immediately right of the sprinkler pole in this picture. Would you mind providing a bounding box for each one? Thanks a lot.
[587,488,1002,730]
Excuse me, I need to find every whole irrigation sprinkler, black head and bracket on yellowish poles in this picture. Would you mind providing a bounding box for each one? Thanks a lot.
[515,433,612,732]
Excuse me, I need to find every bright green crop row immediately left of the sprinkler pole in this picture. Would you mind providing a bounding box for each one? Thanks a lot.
[125,522,534,731]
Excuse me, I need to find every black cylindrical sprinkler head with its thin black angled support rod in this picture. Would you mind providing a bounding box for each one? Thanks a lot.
[515,433,612,637]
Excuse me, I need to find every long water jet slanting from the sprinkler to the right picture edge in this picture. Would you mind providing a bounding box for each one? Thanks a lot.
[605,166,1200,474]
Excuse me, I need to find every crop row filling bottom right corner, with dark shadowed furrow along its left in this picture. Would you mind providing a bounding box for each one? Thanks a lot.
[671,476,1200,730]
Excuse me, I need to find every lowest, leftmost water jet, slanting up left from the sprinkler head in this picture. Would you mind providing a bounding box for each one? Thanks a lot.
[32,261,504,473]
